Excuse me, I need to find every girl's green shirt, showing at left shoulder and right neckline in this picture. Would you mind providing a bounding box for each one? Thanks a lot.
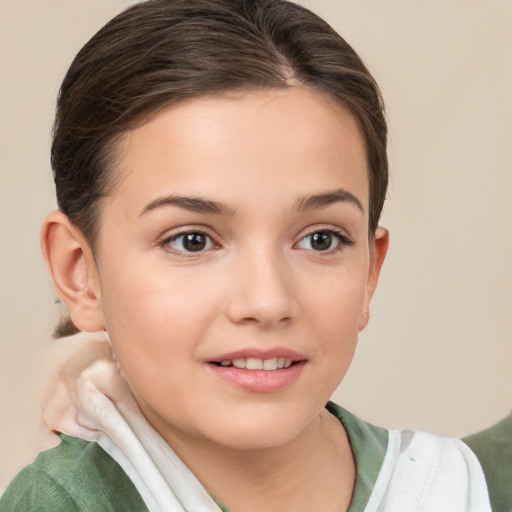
[0,403,387,512]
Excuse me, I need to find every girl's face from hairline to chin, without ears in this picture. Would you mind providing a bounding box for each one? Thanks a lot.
[89,88,384,448]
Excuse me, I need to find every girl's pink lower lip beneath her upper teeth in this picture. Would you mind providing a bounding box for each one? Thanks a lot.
[208,361,306,393]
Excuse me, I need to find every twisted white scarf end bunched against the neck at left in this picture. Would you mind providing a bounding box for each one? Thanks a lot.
[46,340,220,512]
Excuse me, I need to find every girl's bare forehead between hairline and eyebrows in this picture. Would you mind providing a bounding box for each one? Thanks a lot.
[111,87,368,215]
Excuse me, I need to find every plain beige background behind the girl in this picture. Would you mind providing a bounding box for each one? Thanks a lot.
[0,0,512,487]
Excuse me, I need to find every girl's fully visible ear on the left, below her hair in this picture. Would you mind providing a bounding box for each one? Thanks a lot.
[41,211,105,332]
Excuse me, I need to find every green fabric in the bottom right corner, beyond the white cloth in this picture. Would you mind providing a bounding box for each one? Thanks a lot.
[463,414,512,512]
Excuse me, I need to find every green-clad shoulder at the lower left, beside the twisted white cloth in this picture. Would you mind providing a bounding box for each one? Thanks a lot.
[0,435,147,512]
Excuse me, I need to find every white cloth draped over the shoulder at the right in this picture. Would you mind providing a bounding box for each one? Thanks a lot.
[364,430,491,512]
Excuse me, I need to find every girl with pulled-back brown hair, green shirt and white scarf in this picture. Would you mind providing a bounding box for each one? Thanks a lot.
[0,0,504,512]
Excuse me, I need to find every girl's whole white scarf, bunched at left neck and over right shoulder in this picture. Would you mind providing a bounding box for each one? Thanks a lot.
[47,336,491,512]
